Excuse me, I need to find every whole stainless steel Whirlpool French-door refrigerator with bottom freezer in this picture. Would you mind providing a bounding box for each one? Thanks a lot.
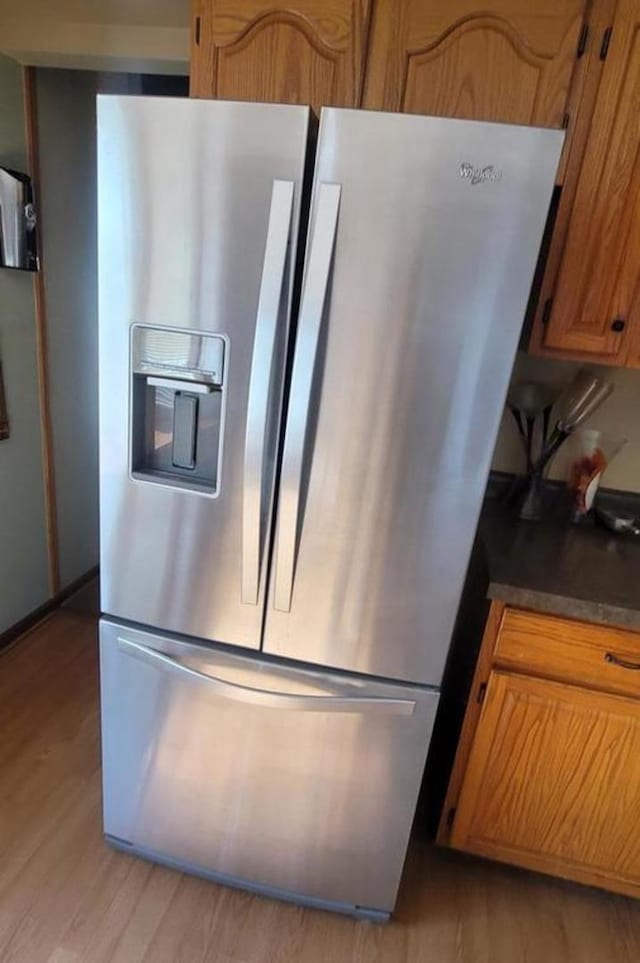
[98,97,562,917]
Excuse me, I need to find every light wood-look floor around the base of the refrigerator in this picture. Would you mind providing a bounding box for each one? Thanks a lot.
[0,609,640,963]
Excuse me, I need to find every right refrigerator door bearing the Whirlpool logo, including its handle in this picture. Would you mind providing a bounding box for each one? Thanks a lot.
[264,109,563,685]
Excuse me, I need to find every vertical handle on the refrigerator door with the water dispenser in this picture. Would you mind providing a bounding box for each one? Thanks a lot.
[241,180,294,605]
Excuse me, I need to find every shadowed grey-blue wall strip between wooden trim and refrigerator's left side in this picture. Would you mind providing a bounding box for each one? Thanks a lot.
[36,68,98,588]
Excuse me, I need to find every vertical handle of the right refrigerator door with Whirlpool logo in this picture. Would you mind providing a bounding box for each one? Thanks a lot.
[274,183,341,612]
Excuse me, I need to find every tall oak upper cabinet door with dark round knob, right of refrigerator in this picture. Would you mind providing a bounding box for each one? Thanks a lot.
[543,0,640,364]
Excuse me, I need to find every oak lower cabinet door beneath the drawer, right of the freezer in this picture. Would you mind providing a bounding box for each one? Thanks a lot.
[451,672,640,895]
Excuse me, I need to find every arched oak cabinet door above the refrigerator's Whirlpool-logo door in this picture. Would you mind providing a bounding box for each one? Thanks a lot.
[363,0,589,127]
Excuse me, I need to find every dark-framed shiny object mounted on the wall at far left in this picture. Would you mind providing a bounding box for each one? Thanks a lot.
[0,167,38,271]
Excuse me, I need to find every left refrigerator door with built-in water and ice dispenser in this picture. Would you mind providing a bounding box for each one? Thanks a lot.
[98,97,308,648]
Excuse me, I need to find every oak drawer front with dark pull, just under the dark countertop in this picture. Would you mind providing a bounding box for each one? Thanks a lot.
[494,609,640,696]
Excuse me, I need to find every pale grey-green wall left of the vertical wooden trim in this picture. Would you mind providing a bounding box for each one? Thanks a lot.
[0,55,49,632]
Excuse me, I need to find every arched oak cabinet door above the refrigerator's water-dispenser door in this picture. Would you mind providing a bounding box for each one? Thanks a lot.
[190,0,370,110]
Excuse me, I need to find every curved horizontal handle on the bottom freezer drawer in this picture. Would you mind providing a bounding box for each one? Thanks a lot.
[118,638,416,716]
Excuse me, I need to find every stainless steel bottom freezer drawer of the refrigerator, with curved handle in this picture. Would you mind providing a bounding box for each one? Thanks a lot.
[100,620,438,913]
